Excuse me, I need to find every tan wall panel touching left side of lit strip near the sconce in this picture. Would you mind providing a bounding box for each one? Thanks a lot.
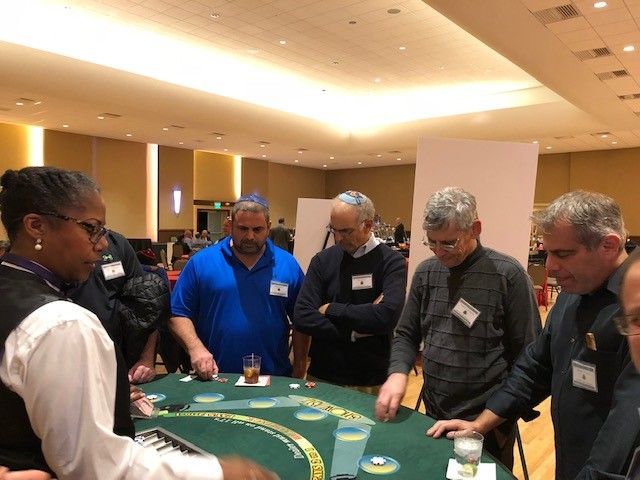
[95,138,147,238]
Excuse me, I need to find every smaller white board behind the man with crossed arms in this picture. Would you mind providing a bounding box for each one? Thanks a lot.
[293,198,334,273]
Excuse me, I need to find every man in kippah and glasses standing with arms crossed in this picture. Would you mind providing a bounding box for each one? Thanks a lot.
[294,191,406,394]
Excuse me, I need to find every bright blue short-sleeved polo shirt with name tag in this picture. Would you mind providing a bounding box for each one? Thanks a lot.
[171,237,304,376]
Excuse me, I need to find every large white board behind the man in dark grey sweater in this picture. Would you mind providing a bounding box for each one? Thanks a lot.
[409,138,538,279]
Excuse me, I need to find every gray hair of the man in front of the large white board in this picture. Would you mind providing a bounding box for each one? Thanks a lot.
[422,187,478,231]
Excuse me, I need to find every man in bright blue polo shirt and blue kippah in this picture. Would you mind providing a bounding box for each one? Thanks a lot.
[170,194,309,379]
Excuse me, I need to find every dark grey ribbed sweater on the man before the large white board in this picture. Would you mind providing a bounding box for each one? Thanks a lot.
[389,245,541,419]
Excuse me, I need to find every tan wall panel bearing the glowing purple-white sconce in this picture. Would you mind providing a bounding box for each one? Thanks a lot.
[158,146,194,230]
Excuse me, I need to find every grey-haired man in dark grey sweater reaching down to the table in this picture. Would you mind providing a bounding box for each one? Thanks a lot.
[376,187,541,468]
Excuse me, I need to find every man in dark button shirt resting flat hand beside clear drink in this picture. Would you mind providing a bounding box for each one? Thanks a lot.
[427,191,637,480]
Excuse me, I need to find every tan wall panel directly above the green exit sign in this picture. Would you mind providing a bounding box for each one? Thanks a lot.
[193,151,236,202]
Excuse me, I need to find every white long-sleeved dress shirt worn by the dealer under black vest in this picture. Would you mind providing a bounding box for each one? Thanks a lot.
[0,301,222,480]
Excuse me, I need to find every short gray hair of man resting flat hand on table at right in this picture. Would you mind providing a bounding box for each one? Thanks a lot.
[531,190,627,250]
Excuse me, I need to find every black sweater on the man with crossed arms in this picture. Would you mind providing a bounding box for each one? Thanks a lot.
[293,245,406,386]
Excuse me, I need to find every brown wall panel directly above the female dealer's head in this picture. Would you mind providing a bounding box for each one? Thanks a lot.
[44,130,94,175]
